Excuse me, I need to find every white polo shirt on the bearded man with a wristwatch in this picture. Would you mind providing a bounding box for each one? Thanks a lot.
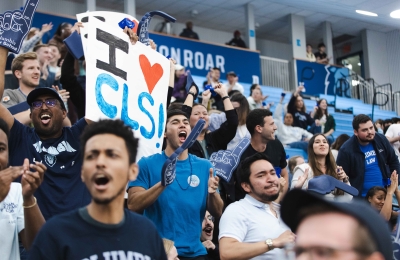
[218,194,289,260]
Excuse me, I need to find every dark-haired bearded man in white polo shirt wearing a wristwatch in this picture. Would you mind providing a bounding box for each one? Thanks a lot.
[219,153,295,260]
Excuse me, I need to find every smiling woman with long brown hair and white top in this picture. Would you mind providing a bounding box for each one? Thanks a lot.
[291,134,351,197]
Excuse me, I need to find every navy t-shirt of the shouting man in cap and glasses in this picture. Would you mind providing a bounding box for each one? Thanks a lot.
[8,119,91,219]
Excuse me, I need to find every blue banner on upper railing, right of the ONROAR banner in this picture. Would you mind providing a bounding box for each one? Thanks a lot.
[296,60,349,96]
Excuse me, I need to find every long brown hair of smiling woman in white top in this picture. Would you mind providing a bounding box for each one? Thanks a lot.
[307,133,344,195]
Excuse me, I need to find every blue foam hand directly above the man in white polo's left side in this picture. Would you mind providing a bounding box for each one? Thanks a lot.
[210,138,250,182]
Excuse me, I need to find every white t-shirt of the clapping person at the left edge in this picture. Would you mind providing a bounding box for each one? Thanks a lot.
[0,182,25,260]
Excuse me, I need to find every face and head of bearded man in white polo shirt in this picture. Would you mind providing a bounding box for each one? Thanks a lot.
[242,160,280,203]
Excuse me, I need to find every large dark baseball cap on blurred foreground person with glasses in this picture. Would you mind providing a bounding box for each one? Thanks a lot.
[281,189,393,259]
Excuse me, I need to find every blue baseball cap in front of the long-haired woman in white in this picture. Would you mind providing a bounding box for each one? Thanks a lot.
[307,174,358,196]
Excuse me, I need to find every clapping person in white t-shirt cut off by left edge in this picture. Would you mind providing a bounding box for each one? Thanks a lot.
[0,119,46,260]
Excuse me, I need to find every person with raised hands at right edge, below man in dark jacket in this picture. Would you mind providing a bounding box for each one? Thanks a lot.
[365,173,400,221]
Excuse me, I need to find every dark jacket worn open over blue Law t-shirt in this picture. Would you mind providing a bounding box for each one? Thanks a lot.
[336,133,400,196]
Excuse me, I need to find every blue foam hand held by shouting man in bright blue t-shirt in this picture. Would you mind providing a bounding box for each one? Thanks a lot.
[161,119,206,187]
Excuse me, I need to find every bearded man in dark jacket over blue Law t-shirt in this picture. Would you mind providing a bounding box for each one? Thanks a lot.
[336,114,400,197]
